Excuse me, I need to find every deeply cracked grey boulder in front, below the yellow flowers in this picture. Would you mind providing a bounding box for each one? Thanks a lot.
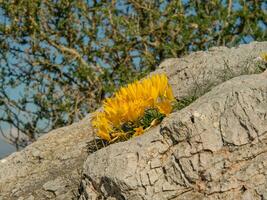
[80,71,267,200]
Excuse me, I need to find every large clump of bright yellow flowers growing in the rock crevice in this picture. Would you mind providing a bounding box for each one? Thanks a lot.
[92,74,174,141]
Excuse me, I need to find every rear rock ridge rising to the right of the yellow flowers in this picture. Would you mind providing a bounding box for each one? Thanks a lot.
[157,42,267,99]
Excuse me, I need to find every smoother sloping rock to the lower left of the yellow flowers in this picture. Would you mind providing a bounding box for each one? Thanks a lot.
[0,116,93,200]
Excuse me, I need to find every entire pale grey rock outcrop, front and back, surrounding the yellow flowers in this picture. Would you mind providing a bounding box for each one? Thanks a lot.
[0,42,267,200]
